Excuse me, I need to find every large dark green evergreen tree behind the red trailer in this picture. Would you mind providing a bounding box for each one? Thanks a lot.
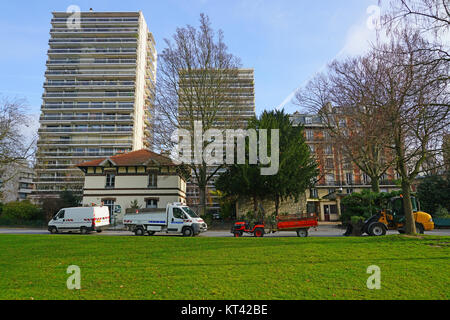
[215,111,318,215]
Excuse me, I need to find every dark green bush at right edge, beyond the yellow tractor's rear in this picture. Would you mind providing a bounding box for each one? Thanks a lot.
[417,176,450,215]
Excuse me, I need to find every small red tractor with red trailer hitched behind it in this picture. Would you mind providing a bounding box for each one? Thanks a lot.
[231,215,318,238]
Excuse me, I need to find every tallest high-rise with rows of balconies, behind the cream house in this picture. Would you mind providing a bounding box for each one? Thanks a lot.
[35,11,157,197]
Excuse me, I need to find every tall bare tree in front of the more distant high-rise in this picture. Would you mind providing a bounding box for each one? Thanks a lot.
[153,14,240,214]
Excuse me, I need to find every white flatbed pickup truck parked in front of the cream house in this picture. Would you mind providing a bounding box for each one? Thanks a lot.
[123,203,208,237]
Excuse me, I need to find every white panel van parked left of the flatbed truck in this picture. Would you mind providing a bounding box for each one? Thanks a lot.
[48,207,109,234]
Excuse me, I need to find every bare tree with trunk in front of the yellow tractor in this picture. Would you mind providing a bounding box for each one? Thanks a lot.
[377,29,450,234]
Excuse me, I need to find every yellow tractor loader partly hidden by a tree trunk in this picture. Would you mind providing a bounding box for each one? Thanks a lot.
[363,196,434,236]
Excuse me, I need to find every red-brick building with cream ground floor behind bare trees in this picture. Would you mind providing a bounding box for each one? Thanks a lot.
[291,112,399,221]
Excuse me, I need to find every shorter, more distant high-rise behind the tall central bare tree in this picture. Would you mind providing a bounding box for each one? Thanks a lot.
[180,69,255,213]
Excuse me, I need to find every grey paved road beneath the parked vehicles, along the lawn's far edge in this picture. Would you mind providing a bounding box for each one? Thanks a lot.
[0,225,450,238]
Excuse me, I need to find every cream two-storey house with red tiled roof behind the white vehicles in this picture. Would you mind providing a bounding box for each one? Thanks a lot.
[77,149,186,224]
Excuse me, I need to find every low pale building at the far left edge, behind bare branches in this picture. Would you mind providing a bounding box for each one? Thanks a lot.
[0,160,35,203]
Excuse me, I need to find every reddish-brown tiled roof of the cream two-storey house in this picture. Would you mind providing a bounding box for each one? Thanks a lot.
[76,149,175,168]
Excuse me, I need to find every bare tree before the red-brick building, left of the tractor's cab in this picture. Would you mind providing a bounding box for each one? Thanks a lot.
[296,55,393,192]
